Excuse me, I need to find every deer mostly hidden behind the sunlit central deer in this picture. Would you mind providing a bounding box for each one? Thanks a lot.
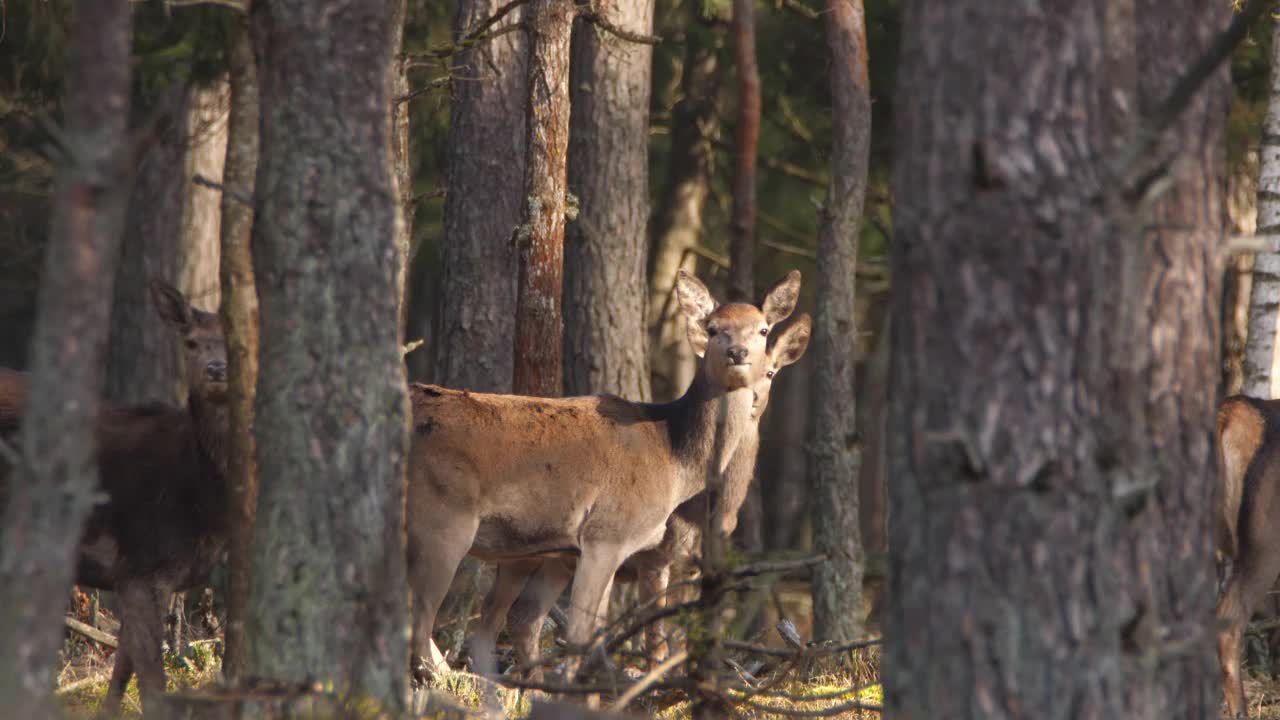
[472,314,812,678]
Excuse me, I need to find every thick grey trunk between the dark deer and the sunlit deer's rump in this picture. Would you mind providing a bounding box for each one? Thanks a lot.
[246,0,408,715]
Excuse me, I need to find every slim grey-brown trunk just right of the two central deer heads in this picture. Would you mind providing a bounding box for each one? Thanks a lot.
[808,0,872,642]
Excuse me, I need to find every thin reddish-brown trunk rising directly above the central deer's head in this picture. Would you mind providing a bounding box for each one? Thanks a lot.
[728,0,760,302]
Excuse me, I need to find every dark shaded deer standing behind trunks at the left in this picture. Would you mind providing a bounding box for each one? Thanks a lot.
[0,281,228,714]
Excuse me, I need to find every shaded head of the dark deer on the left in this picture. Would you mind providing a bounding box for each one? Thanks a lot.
[151,279,227,401]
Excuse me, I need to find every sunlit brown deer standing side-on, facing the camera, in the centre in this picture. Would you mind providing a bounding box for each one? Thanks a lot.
[406,272,800,679]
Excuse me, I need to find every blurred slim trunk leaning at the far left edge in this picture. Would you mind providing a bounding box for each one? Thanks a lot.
[0,0,131,717]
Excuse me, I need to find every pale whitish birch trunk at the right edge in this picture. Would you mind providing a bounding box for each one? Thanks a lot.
[1242,23,1280,397]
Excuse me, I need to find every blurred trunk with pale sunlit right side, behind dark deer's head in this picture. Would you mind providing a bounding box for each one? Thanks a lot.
[106,83,227,406]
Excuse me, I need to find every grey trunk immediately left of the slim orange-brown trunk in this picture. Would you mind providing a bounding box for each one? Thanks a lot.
[433,0,527,392]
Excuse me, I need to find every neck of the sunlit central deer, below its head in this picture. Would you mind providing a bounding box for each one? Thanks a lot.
[671,372,754,502]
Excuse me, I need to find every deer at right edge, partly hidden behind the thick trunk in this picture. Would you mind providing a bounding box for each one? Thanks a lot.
[1216,395,1280,717]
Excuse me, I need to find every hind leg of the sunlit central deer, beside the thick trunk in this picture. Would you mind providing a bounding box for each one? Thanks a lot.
[406,504,480,683]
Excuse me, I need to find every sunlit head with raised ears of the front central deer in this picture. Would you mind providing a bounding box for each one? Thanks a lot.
[676,270,800,391]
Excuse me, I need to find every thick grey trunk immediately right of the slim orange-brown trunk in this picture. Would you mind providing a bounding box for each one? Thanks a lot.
[564,0,654,401]
